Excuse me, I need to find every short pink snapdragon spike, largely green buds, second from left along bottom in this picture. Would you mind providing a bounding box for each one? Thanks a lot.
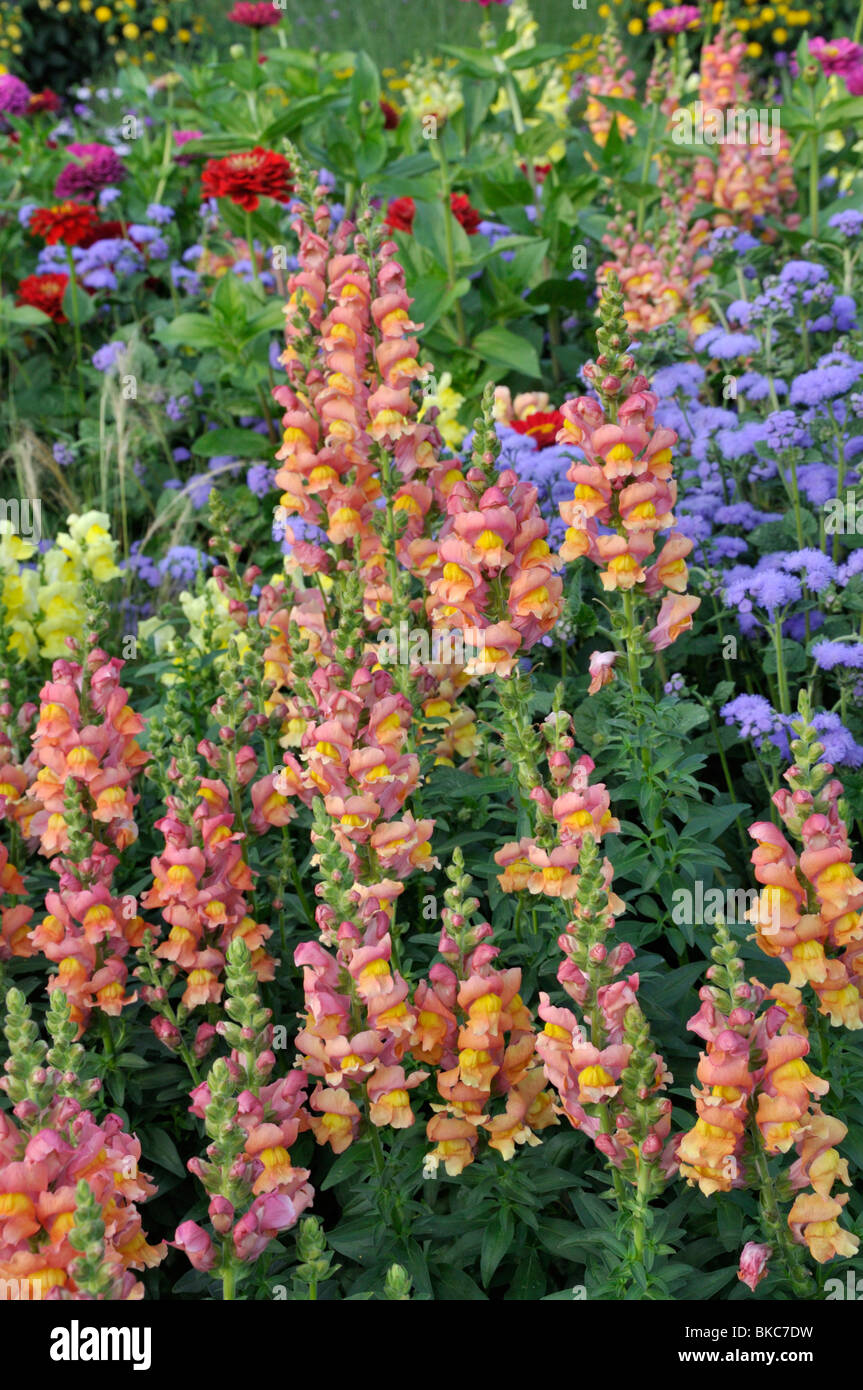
[172,940,314,1298]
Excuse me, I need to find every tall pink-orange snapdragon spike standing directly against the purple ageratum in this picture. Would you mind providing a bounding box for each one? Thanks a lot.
[557,275,700,669]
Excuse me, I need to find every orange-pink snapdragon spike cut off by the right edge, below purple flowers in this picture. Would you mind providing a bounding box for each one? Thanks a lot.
[749,701,863,1030]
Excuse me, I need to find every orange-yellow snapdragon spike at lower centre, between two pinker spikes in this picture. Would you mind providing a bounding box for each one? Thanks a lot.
[411,848,557,1177]
